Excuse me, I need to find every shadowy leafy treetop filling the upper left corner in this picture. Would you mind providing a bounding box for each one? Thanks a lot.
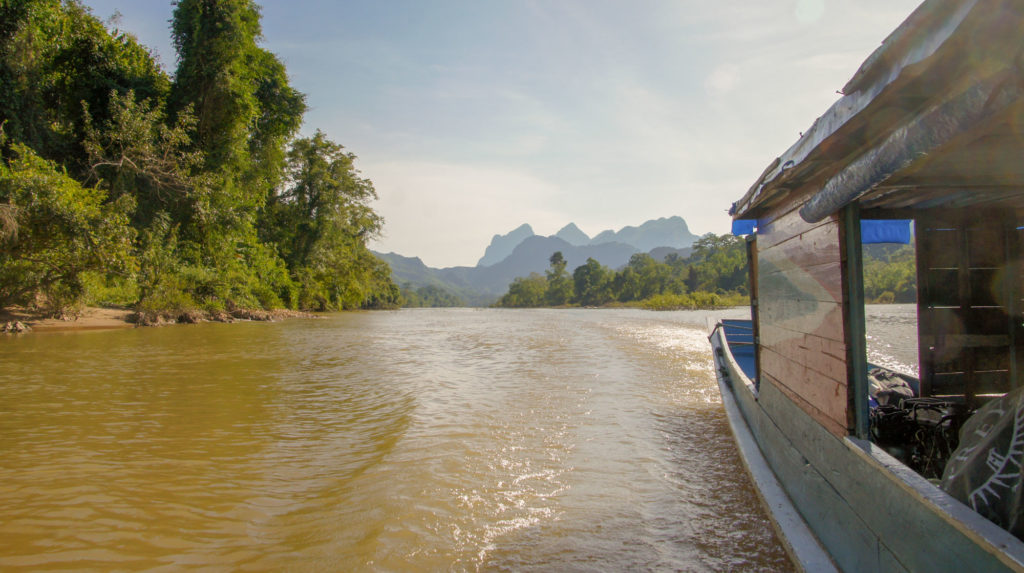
[0,0,170,169]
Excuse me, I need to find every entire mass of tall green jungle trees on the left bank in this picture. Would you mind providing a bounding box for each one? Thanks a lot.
[0,0,400,318]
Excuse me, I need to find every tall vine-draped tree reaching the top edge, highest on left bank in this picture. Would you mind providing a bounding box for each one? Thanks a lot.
[170,0,306,217]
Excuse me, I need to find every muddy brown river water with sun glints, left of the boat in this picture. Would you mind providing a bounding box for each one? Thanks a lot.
[0,310,790,571]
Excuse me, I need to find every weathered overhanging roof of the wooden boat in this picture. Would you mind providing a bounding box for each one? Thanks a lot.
[731,0,1024,222]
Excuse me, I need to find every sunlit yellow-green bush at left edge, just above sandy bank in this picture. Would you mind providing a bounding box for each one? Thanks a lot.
[0,144,134,314]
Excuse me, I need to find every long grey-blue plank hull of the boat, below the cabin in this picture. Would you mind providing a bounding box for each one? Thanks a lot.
[711,327,1024,571]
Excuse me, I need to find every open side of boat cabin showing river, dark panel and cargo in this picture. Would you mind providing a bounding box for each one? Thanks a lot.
[861,211,1024,482]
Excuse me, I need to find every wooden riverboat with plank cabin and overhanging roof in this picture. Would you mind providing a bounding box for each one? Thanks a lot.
[710,0,1024,572]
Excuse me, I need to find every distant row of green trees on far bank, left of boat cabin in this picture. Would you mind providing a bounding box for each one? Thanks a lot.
[497,234,748,308]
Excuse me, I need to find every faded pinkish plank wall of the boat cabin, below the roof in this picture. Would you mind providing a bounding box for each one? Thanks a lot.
[757,201,849,436]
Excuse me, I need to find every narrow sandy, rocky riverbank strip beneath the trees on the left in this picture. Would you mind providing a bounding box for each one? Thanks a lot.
[0,307,316,334]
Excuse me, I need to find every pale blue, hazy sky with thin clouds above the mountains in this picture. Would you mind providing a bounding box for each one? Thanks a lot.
[83,0,920,267]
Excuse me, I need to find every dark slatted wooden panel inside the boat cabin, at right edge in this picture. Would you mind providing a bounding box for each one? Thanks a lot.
[915,209,1024,402]
